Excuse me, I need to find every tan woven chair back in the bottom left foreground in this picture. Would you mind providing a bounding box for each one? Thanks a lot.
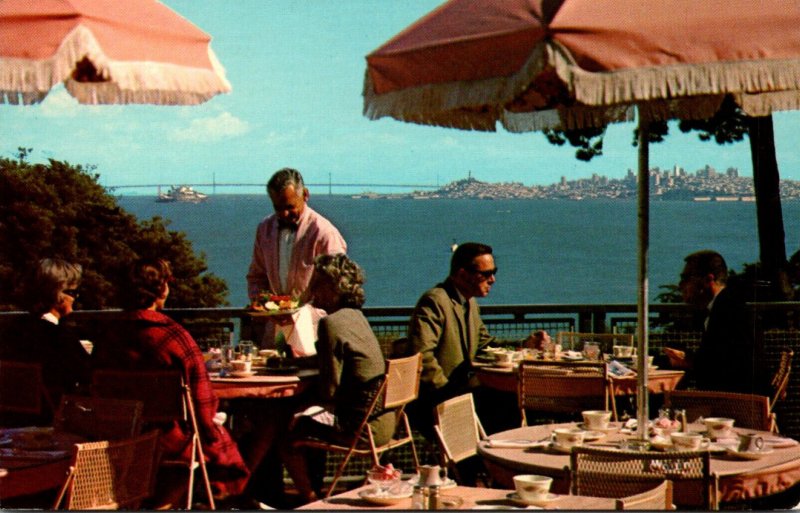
[56,431,158,510]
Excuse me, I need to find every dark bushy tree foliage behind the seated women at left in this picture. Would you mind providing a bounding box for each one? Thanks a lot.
[0,148,228,310]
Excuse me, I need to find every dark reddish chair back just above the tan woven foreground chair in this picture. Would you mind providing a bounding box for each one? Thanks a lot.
[53,395,143,440]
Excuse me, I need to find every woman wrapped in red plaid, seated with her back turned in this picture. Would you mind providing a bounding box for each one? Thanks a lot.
[96,260,250,498]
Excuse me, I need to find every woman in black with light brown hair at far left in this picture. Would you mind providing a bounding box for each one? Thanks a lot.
[0,258,90,412]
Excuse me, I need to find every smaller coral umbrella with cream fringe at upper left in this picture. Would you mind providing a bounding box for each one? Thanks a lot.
[0,0,231,105]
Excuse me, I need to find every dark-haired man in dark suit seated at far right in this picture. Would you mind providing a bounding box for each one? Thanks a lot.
[664,250,763,393]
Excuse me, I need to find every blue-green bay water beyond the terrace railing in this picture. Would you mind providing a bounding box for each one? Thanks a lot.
[119,194,800,306]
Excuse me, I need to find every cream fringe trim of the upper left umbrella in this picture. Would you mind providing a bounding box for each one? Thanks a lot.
[0,25,231,105]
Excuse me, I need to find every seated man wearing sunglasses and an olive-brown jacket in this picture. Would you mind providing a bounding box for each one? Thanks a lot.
[408,242,536,439]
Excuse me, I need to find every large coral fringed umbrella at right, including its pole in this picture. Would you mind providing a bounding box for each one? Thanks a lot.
[364,0,800,436]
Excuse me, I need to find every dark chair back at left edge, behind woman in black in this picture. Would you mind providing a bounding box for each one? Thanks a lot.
[0,360,53,415]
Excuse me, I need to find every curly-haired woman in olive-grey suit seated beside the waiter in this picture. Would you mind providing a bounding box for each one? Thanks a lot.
[281,254,395,502]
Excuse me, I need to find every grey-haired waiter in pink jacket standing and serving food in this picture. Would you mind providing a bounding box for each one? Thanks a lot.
[247,168,347,310]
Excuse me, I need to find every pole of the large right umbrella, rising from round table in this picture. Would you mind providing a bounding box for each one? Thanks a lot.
[636,112,650,440]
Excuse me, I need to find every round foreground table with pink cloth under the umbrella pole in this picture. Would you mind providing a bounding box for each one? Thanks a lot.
[478,423,800,505]
